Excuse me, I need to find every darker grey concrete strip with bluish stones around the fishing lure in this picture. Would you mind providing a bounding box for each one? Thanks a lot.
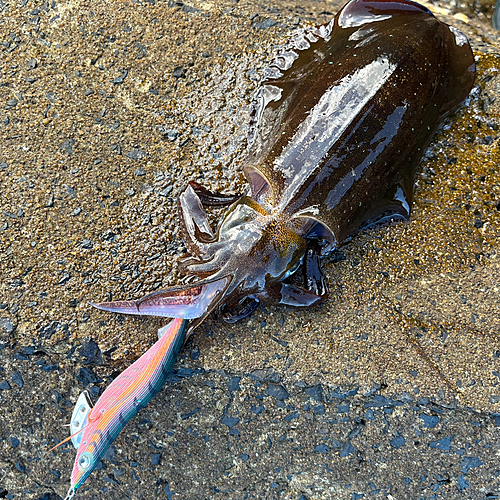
[0,338,500,499]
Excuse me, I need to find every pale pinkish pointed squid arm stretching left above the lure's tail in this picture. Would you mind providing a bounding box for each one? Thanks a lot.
[89,276,231,319]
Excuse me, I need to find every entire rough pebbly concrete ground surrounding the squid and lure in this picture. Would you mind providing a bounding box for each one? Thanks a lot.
[0,0,500,500]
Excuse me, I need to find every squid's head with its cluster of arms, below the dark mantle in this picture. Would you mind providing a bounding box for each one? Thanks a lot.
[92,178,327,332]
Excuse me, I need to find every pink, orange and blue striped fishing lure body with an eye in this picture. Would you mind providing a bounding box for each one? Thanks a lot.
[60,318,188,500]
